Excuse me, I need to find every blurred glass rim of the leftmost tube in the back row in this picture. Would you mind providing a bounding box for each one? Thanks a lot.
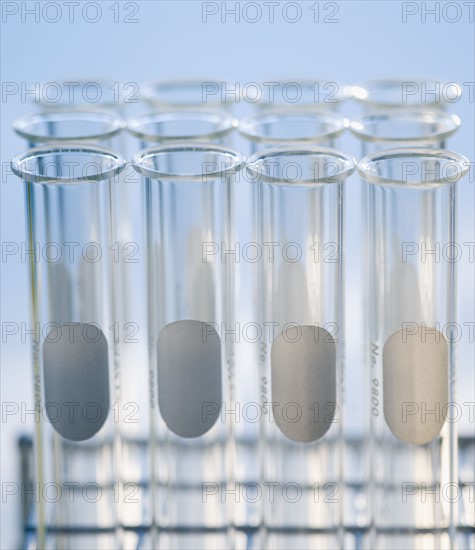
[30,77,129,111]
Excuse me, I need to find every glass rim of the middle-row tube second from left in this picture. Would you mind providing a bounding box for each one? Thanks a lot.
[127,109,239,143]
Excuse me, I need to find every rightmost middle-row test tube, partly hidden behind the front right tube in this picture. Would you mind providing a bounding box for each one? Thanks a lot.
[347,107,461,540]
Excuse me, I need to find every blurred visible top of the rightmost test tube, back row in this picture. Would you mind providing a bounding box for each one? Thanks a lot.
[351,77,462,111]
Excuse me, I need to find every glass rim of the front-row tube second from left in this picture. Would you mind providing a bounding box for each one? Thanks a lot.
[132,141,245,183]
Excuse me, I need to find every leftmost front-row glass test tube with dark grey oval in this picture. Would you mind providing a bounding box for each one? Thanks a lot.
[12,143,125,549]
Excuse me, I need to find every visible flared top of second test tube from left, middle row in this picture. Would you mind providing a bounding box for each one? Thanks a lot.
[127,109,238,149]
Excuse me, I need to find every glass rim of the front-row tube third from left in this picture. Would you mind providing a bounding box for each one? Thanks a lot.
[246,146,356,187]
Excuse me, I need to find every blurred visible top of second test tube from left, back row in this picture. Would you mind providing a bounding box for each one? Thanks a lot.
[141,78,240,111]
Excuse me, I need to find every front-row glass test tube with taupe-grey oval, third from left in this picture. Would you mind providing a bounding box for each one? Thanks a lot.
[248,147,354,548]
